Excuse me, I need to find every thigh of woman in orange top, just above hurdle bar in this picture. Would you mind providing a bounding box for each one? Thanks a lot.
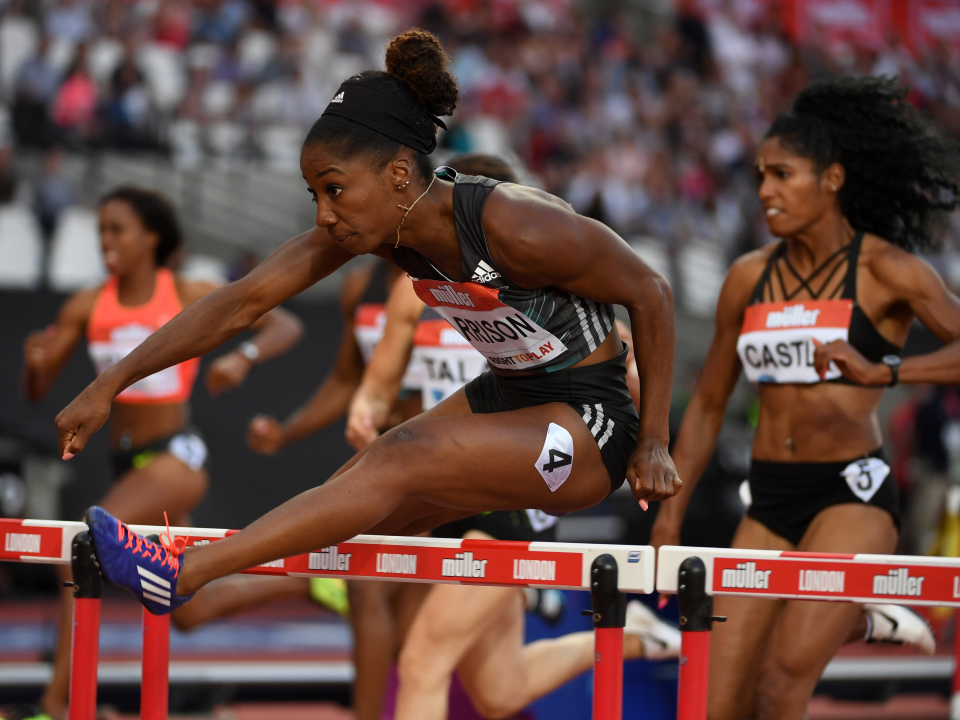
[100,453,209,525]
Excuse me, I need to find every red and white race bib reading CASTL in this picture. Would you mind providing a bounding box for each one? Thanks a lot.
[737,300,853,384]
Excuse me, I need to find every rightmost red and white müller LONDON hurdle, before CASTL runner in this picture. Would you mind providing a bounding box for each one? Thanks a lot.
[657,546,960,720]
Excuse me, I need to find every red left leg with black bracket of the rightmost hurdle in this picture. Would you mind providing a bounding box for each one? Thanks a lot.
[677,557,726,720]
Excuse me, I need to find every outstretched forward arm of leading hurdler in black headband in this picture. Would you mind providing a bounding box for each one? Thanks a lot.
[56,228,353,459]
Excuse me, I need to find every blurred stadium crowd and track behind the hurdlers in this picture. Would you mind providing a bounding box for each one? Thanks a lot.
[0,0,960,720]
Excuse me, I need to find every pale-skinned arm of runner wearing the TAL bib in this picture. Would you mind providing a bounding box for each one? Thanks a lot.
[346,278,424,450]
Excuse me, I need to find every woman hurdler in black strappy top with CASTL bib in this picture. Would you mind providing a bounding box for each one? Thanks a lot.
[653,78,960,720]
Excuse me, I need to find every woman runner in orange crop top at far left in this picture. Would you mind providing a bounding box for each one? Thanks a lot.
[23,187,303,718]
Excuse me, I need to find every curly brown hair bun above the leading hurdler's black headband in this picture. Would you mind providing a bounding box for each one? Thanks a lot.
[386,28,460,115]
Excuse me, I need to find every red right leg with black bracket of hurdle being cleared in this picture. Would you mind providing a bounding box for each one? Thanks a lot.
[590,554,627,720]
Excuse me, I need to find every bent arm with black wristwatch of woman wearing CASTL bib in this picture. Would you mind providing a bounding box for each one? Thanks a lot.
[814,248,960,386]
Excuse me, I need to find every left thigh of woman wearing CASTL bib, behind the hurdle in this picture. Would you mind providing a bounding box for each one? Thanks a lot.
[708,517,794,720]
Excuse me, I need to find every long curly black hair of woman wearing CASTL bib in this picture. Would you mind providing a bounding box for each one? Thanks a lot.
[766,77,960,252]
